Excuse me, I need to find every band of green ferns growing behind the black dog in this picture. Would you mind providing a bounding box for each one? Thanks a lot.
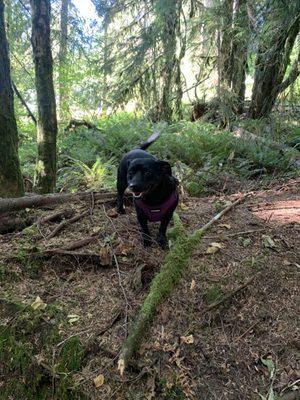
[20,113,300,195]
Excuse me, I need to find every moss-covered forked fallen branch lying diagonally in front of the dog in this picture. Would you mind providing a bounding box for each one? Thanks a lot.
[118,195,247,375]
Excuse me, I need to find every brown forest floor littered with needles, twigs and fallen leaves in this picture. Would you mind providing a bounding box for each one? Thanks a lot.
[0,179,300,400]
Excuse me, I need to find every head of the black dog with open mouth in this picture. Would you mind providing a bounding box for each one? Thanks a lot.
[127,158,172,197]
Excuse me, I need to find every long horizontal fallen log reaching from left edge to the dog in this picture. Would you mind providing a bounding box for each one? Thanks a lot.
[0,190,116,215]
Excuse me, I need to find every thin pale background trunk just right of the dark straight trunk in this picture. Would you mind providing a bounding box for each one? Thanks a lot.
[58,0,70,120]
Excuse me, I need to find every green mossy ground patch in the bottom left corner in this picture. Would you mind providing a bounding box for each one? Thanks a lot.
[0,295,85,400]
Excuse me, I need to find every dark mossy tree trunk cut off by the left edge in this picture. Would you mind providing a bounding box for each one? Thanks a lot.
[0,0,24,197]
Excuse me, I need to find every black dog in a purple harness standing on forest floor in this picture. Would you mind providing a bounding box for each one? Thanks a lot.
[117,133,178,248]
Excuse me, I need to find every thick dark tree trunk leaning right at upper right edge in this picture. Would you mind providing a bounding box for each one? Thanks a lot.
[249,14,300,119]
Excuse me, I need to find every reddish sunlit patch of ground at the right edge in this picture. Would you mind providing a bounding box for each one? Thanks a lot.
[252,199,300,225]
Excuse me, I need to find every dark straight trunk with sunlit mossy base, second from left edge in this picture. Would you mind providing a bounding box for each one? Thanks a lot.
[30,0,57,193]
